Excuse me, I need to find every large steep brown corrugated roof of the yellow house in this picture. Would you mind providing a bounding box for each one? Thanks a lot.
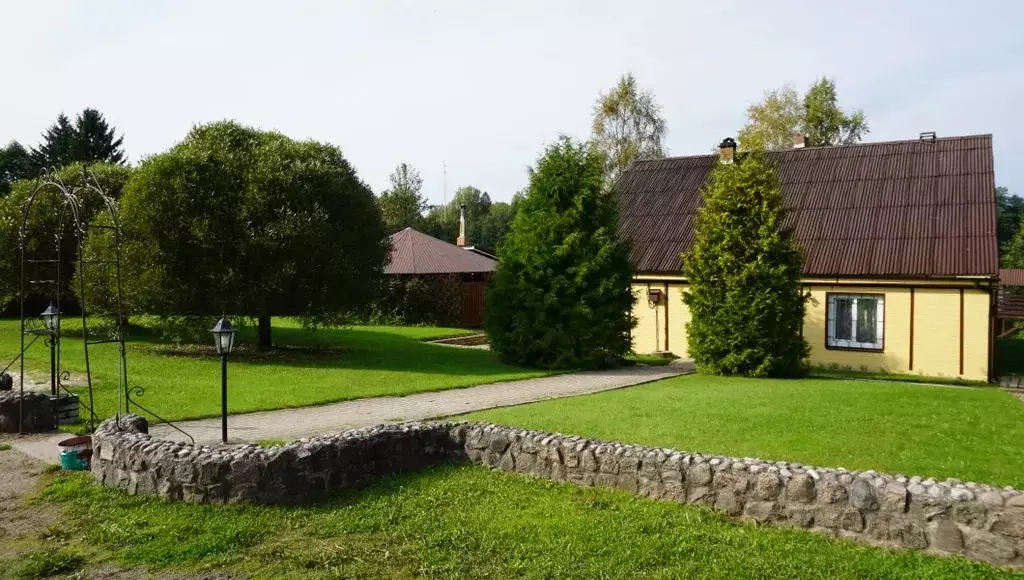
[615,135,998,278]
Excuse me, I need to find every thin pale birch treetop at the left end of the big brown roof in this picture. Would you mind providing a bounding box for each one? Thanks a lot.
[591,73,667,183]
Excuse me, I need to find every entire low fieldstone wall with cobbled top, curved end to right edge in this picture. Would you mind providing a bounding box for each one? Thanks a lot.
[92,419,1024,567]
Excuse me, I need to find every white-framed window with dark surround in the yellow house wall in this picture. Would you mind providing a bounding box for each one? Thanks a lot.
[825,294,886,350]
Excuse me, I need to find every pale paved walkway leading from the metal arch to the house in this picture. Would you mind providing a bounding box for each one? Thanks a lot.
[11,363,692,462]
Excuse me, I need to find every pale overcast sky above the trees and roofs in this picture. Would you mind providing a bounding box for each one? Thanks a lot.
[0,0,1024,203]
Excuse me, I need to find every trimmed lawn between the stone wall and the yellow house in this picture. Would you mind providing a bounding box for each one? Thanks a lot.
[464,375,1024,487]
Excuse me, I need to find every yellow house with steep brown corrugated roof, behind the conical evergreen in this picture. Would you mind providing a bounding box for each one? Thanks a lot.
[615,133,998,380]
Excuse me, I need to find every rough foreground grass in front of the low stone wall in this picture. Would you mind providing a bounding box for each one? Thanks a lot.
[28,465,1010,579]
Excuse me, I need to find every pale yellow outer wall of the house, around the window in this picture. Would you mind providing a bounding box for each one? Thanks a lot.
[633,277,990,380]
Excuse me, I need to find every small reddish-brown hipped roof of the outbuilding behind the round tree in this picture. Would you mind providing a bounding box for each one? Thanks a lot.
[384,227,498,274]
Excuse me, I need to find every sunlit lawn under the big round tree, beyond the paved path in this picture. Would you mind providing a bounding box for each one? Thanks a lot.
[0,319,544,420]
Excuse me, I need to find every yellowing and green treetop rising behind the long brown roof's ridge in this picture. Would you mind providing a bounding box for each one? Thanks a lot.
[738,77,868,151]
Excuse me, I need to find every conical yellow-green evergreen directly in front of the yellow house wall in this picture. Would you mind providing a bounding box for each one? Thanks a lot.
[683,152,808,376]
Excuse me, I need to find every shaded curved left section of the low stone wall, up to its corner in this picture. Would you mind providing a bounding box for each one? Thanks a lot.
[91,415,455,503]
